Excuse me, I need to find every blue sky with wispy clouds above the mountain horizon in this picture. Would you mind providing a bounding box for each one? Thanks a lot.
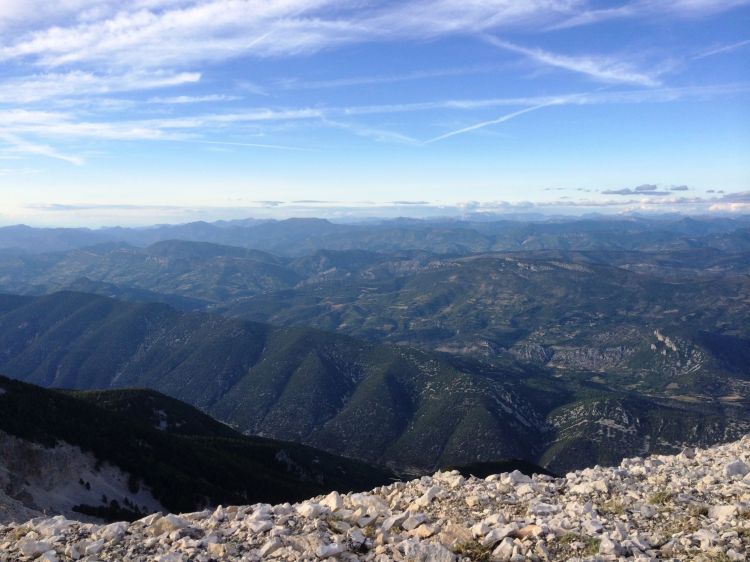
[0,0,750,226]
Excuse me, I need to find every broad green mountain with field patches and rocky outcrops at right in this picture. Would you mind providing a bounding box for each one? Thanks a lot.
[219,251,750,399]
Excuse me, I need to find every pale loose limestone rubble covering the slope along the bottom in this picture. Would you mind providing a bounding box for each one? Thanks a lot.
[0,436,750,562]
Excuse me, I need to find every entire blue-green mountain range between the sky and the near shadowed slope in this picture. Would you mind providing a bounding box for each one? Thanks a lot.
[0,217,750,482]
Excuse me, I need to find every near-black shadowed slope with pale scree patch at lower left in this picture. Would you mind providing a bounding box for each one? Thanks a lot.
[0,377,393,519]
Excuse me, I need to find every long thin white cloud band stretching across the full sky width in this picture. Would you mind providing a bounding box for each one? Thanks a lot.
[0,83,750,155]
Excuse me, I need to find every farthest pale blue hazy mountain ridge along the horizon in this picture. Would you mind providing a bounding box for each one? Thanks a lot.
[0,216,750,256]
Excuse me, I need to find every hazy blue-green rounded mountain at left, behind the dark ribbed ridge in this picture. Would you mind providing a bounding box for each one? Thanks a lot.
[0,240,302,308]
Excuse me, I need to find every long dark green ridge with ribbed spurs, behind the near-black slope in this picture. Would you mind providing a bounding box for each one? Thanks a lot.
[0,292,750,474]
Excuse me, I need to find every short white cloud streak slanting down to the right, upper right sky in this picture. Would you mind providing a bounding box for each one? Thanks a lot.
[485,35,660,86]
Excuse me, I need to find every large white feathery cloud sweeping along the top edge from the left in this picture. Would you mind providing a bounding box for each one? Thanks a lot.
[0,0,586,68]
